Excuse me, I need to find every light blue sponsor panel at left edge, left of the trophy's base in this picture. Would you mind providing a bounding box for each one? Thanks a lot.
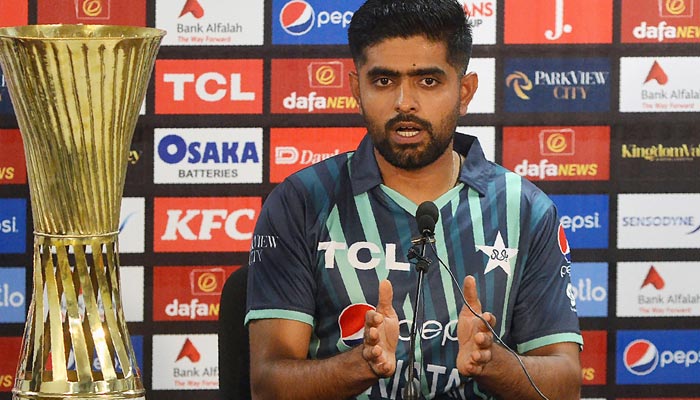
[0,267,27,323]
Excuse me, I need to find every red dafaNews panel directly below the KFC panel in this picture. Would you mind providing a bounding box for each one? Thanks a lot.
[153,266,238,321]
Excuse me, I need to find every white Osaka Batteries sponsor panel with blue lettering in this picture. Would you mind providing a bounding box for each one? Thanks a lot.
[153,128,262,184]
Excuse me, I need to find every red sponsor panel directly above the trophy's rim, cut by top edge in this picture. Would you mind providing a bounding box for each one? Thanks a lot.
[37,0,146,26]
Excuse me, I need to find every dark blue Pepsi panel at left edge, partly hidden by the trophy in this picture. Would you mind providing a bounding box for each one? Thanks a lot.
[0,199,27,254]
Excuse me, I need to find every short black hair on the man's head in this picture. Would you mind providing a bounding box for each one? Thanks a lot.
[348,0,472,73]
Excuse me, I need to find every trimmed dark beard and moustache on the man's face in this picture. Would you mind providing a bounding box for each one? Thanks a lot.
[367,110,459,171]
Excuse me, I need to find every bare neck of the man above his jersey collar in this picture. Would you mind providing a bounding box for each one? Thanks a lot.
[374,146,461,204]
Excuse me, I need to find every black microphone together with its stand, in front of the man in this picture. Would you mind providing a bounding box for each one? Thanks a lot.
[402,201,440,400]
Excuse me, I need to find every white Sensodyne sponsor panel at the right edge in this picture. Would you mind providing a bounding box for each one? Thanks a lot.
[617,193,700,249]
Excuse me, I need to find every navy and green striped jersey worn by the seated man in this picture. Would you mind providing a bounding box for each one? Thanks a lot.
[246,134,582,399]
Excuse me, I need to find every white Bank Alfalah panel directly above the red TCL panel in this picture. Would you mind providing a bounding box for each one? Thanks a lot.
[156,0,265,46]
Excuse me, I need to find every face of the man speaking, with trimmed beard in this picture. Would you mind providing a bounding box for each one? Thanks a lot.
[350,36,477,170]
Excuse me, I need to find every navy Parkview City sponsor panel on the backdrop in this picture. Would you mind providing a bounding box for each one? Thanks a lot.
[504,58,611,112]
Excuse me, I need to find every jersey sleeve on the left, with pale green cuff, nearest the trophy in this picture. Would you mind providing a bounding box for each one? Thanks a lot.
[245,180,316,326]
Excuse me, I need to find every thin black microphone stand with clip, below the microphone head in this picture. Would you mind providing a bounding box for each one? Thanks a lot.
[402,232,435,400]
